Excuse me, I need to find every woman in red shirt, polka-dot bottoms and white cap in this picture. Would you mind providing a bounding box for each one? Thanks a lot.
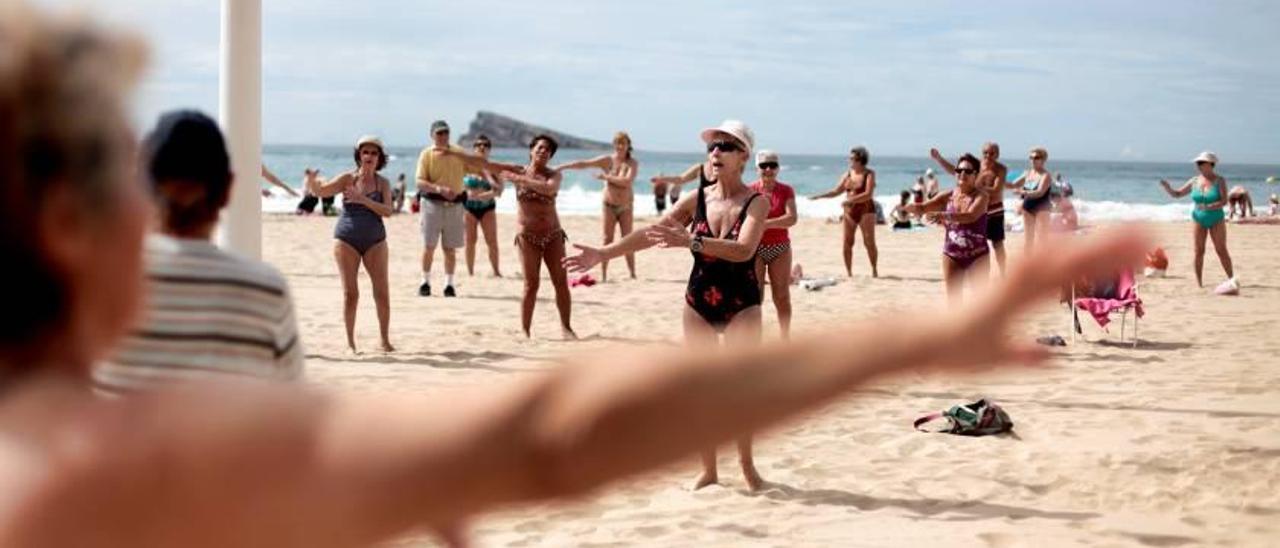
[751,150,796,339]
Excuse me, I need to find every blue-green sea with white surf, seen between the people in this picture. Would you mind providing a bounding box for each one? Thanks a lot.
[262,145,1280,223]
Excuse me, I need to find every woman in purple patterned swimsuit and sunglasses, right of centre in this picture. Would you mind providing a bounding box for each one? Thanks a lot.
[906,154,989,305]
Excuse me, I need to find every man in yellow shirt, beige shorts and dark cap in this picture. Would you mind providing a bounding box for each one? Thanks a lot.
[417,120,467,297]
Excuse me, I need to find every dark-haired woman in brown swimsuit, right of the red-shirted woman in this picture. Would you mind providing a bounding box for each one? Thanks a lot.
[809,146,879,278]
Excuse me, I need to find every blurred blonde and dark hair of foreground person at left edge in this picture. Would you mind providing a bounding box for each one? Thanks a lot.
[0,1,146,352]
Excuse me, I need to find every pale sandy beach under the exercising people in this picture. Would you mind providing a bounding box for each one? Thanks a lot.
[264,214,1280,547]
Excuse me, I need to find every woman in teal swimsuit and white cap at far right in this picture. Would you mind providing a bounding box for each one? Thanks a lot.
[1160,151,1235,287]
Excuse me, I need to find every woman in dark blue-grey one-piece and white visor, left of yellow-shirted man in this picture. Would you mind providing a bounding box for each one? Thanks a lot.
[306,136,396,352]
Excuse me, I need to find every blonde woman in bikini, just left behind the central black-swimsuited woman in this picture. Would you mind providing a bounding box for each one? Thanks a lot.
[552,132,640,282]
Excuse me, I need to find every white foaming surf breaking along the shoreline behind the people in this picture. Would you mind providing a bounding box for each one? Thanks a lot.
[262,184,1192,223]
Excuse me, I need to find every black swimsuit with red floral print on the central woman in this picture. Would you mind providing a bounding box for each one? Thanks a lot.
[685,188,760,333]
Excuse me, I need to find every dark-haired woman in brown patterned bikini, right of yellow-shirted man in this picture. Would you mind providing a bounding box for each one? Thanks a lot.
[444,134,577,339]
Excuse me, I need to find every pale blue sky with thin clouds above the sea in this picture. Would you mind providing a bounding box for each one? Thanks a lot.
[41,0,1280,164]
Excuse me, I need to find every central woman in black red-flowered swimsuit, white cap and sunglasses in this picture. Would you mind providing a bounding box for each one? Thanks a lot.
[564,120,769,490]
